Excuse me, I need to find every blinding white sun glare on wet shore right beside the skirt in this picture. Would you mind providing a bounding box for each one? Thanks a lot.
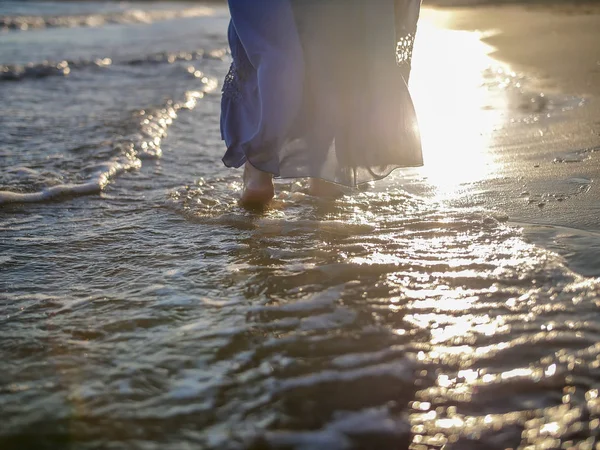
[410,9,508,197]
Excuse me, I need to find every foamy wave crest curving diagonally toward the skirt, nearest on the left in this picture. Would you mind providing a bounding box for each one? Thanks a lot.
[0,77,217,205]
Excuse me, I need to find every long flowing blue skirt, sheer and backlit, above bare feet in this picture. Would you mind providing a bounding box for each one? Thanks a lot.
[221,0,423,186]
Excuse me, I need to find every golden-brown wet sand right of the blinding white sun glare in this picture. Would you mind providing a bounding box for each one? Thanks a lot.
[422,3,600,239]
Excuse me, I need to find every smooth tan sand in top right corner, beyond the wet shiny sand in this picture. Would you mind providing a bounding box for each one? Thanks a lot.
[432,3,600,95]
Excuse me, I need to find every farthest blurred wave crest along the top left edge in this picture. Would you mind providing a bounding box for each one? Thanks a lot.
[0,6,213,31]
